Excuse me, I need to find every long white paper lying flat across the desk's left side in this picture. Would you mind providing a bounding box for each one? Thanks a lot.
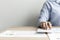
[0,30,47,37]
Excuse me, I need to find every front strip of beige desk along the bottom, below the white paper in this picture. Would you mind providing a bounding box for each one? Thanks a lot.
[0,37,48,40]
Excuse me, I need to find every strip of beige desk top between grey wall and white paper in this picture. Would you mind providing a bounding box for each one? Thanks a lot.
[7,26,37,31]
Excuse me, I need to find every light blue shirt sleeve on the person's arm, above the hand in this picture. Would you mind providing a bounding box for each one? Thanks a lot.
[38,1,51,23]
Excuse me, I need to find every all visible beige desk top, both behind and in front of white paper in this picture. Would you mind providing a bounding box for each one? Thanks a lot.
[0,26,48,40]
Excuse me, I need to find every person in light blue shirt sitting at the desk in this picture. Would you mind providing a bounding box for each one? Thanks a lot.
[39,0,60,29]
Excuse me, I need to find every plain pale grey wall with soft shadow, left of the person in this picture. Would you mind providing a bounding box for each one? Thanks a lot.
[0,0,45,30]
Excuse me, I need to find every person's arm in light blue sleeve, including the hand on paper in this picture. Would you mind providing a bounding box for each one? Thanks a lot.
[39,2,52,29]
